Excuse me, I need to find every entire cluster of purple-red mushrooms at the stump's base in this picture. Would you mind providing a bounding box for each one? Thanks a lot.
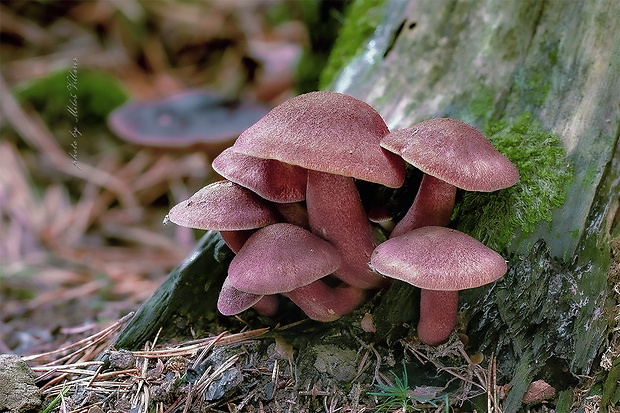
[168,92,519,344]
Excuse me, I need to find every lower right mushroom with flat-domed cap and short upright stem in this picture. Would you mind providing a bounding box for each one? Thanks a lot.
[370,226,507,345]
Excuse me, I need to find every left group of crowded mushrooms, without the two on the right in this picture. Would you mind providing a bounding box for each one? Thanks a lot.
[168,92,405,321]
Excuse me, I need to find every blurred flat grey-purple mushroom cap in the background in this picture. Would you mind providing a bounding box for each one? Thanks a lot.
[108,90,268,159]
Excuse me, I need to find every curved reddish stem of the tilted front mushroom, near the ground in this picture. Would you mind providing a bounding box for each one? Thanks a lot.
[286,280,364,322]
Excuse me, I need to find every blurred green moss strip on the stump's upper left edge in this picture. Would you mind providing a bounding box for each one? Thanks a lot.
[319,0,385,89]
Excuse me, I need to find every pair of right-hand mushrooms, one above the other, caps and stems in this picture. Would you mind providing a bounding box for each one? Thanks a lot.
[371,118,519,345]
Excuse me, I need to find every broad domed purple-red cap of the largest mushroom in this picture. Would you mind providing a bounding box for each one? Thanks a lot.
[234,91,405,188]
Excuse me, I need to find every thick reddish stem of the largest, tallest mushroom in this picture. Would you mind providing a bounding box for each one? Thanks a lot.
[306,170,386,289]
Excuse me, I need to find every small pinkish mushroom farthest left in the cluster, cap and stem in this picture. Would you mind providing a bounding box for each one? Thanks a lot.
[167,180,279,252]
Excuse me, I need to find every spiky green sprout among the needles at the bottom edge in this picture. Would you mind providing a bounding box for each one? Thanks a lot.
[368,361,449,413]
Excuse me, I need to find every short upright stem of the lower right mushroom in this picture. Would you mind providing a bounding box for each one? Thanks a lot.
[418,289,459,346]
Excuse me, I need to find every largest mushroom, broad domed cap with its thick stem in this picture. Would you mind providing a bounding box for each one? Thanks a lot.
[233,91,405,288]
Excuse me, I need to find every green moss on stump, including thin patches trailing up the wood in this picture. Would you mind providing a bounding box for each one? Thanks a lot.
[453,41,573,250]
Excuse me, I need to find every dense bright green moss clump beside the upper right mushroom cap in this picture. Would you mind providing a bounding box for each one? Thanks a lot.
[453,112,573,250]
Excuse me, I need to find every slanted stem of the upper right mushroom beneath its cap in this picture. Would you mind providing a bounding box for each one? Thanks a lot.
[390,174,456,238]
